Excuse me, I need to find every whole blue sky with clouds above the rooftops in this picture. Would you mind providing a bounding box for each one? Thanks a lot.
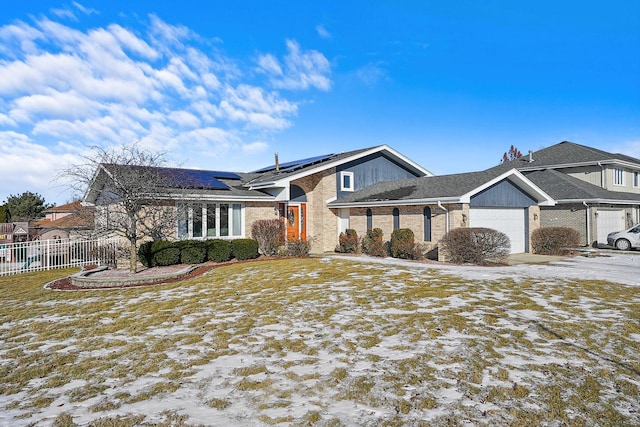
[0,0,640,204]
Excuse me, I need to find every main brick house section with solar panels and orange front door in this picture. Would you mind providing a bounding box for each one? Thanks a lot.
[85,145,432,252]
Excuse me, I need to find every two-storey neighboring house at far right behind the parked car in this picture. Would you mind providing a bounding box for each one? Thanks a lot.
[490,141,640,245]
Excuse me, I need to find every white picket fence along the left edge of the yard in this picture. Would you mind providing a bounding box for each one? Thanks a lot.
[0,237,121,276]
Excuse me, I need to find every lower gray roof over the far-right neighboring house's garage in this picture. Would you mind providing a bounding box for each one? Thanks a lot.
[524,169,640,203]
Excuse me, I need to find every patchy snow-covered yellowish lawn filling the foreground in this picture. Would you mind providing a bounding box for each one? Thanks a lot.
[0,257,640,426]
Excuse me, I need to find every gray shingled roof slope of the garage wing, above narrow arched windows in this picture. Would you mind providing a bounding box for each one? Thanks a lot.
[329,170,503,206]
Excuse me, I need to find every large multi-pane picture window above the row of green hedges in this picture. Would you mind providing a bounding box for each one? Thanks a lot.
[176,203,244,239]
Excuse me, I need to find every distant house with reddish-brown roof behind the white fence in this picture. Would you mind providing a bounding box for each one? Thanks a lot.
[30,201,95,240]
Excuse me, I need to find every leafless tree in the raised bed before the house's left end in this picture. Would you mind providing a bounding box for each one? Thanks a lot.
[61,143,183,273]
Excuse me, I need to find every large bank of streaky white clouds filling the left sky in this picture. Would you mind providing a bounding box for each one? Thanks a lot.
[0,10,331,203]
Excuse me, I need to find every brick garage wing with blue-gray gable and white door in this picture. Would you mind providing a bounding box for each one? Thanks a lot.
[329,169,555,253]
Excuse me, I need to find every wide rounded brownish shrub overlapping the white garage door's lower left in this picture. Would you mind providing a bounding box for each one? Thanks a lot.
[440,227,511,265]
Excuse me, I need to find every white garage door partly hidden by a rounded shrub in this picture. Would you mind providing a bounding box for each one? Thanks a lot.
[469,208,526,254]
